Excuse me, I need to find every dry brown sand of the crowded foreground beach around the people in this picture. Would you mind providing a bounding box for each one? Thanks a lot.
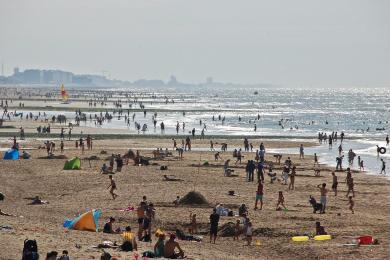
[0,138,390,259]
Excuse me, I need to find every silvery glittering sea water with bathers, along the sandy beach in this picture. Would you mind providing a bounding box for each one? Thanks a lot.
[9,85,390,177]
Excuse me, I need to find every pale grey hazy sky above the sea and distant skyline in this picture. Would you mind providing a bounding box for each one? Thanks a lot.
[0,0,390,87]
